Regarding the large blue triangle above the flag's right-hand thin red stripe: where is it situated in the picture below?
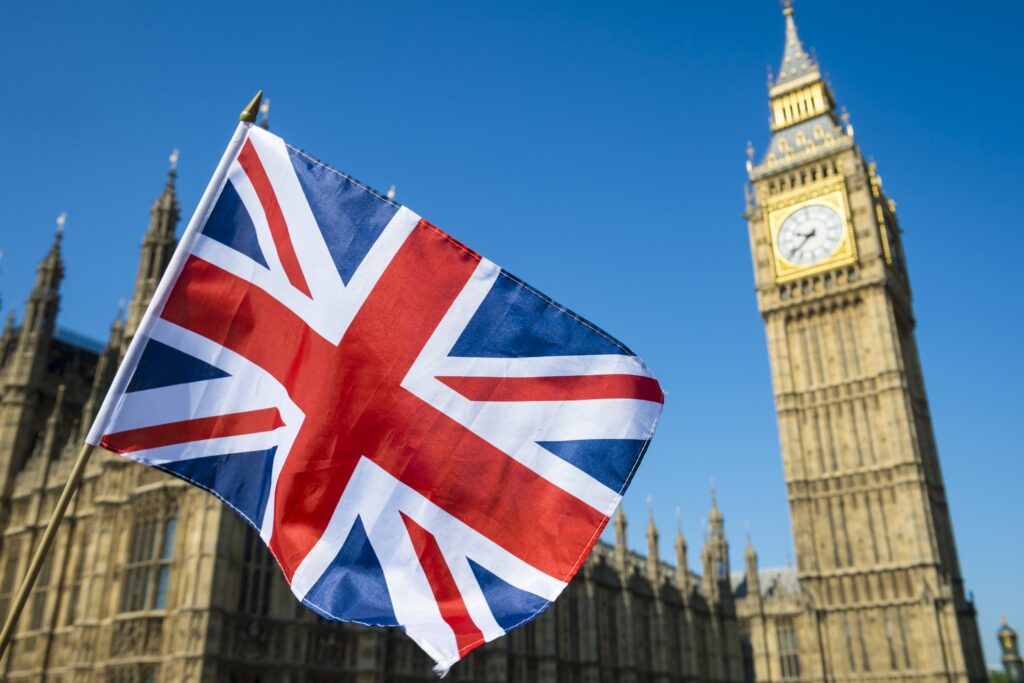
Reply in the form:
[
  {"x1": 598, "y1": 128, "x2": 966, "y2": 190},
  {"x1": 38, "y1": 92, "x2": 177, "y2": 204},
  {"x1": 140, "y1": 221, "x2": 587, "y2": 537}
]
[{"x1": 451, "y1": 270, "x2": 630, "y2": 358}]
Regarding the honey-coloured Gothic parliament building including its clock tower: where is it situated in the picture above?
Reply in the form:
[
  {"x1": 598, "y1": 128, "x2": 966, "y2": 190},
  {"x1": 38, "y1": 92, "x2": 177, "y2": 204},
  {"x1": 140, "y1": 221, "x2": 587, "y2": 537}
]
[{"x1": 0, "y1": 5, "x2": 985, "y2": 683}]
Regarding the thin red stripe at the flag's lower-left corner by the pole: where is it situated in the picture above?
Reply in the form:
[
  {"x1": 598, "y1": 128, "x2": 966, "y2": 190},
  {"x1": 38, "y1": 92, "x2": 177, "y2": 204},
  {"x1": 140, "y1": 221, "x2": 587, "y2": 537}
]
[{"x1": 100, "y1": 408, "x2": 285, "y2": 453}]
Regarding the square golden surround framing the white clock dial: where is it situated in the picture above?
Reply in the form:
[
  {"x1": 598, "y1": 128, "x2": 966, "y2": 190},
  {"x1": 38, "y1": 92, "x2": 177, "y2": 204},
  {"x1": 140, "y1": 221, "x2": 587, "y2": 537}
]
[{"x1": 764, "y1": 182, "x2": 857, "y2": 283}]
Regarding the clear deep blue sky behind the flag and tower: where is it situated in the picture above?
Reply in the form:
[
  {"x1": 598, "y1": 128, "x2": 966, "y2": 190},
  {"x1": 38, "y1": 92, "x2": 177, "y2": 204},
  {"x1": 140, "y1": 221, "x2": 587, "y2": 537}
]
[{"x1": 0, "y1": 0, "x2": 1024, "y2": 661}]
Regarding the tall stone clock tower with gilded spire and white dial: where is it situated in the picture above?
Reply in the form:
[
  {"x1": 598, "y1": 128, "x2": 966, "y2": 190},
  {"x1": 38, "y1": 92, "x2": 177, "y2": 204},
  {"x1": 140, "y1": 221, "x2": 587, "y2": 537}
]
[{"x1": 746, "y1": 3, "x2": 985, "y2": 682}]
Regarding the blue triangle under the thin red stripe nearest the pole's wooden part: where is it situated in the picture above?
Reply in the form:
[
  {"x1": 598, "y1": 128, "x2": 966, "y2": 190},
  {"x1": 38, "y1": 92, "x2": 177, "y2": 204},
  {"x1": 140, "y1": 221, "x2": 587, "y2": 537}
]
[{"x1": 159, "y1": 446, "x2": 278, "y2": 528}]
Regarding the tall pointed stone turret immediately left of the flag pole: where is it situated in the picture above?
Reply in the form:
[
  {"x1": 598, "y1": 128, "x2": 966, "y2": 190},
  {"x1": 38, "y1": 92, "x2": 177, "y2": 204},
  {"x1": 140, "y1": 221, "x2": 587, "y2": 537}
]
[{"x1": 125, "y1": 150, "x2": 179, "y2": 339}]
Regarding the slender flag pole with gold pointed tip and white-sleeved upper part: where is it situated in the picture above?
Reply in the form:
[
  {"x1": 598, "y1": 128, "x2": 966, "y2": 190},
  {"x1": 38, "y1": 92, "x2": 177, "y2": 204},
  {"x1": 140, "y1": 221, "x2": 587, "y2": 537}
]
[{"x1": 0, "y1": 90, "x2": 263, "y2": 658}]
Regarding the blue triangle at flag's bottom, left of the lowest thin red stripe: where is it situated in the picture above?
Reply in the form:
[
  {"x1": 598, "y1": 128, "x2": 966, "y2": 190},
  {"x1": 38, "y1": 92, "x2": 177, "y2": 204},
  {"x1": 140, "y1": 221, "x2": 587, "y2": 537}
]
[{"x1": 302, "y1": 517, "x2": 398, "y2": 626}]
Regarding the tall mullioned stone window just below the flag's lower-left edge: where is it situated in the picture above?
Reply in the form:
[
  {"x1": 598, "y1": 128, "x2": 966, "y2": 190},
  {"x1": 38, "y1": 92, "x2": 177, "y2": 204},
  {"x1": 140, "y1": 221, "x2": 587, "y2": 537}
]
[{"x1": 121, "y1": 507, "x2": 177, "y2": 612}]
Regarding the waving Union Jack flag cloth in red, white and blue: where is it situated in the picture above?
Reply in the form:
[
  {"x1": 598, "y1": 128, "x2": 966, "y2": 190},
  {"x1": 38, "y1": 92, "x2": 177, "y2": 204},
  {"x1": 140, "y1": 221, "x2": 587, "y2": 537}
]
[{"x1": 88, "y1": 126, "x2": 663, "y2": 672}]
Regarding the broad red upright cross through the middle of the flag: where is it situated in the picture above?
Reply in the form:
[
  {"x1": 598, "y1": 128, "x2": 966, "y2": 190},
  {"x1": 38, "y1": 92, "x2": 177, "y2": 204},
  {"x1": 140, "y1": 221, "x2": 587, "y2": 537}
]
[{"x1": 161, "y1": 236, "x2": 607, "y2": 580}]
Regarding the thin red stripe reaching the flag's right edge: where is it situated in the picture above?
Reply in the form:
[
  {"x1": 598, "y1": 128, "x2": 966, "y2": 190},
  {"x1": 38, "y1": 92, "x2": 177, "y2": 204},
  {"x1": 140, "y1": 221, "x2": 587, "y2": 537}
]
[{"x1": 437, "y1": 375, "x2": 665, "y2": 403}]
